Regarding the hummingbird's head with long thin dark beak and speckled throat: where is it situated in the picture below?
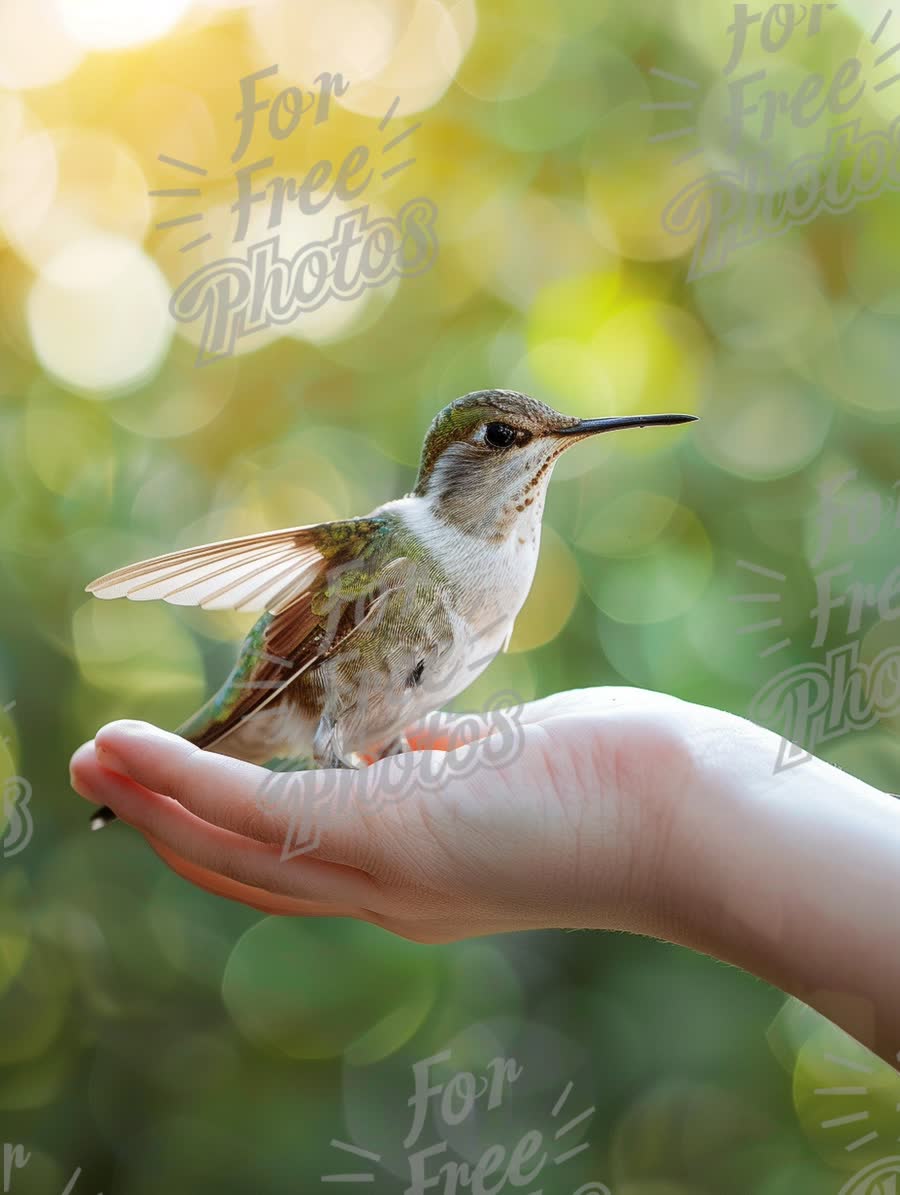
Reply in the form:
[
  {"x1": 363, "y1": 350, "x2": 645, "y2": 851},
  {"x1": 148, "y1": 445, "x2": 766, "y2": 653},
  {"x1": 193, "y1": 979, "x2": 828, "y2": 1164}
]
[{"x1": 412, "y1": 390, "x2": 696, "y2": 540}]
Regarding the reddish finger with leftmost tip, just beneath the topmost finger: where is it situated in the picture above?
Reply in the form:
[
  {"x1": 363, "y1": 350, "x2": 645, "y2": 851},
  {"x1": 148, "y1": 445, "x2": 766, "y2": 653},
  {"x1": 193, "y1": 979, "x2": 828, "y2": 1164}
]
[{"x1": 72, "y1": 752, "x2": 375, "y2": 907}]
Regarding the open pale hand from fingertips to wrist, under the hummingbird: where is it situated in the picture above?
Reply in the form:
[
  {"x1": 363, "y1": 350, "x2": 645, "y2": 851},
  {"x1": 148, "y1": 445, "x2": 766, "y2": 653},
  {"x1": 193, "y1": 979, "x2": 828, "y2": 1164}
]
[{"x1": 66, "y1": 688, "x2": 731, "y2": 943}]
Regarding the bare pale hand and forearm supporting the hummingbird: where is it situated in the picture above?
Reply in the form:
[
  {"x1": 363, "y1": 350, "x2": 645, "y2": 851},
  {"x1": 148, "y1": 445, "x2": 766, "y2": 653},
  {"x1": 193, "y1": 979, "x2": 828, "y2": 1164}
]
[{"x1": 72, "y1": 688, "x2": 900, "y2": 1066}]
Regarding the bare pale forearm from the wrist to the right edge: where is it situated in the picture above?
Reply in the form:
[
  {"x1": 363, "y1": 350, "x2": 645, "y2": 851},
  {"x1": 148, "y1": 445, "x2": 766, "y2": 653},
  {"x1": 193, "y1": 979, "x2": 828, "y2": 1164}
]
[{"x1": 665, "y1": 728, "x2": 900, "y2": 1065}]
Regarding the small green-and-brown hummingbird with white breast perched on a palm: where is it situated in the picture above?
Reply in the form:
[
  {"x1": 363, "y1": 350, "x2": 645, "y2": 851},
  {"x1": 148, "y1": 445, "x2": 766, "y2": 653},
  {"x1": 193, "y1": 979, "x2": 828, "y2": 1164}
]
[{"x1": 87, "y1": 390, "x2": 696, "y2": 829}]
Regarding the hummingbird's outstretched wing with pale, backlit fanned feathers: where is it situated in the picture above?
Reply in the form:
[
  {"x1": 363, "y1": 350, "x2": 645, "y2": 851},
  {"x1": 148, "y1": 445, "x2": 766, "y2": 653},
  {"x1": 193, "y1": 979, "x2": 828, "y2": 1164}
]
[{"x1": 87, "y1": 519, "x2": 346, "y2": 611}]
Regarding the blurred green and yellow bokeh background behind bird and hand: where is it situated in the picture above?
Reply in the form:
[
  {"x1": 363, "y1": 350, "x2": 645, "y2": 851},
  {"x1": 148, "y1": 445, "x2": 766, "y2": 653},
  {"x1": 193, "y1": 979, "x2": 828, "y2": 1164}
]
[{"x1": 0, "y1": 0, "x2": 900, "y2": 1195}]
